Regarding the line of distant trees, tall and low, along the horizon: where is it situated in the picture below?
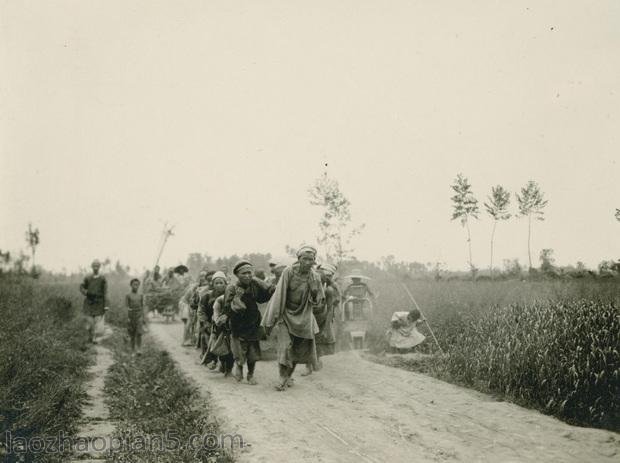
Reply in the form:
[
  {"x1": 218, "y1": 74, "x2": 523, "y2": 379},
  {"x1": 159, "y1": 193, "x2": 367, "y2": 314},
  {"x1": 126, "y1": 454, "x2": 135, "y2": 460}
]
[{"x1": 0, "y1": 173, "x2": 620, "y2": 279}]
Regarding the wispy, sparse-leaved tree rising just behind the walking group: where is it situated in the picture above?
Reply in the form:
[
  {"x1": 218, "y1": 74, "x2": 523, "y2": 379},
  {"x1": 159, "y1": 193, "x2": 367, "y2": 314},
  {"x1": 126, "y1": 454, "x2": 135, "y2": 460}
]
[{"x1": 308, "y1": 174, "x2": 364, "y2": 264}]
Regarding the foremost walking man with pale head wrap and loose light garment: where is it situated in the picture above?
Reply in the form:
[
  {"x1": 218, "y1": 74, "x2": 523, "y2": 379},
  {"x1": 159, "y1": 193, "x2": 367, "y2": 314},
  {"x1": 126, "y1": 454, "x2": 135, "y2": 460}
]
[{"x1": 262, "y1": 246, "x2": 325, "y2": 391}]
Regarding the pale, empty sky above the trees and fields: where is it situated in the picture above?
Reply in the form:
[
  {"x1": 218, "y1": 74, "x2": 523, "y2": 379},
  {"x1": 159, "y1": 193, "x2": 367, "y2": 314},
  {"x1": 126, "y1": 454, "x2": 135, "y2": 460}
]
[{"x1": 0, "y1": 0, "x2": 620, "y2": 271}]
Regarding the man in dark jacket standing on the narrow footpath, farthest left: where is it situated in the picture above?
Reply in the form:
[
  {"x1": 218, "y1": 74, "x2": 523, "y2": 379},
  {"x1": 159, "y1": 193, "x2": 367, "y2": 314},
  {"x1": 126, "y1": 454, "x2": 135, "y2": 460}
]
[{"x1": 80, "y1": 259, "x2": 108, "y2": 344}]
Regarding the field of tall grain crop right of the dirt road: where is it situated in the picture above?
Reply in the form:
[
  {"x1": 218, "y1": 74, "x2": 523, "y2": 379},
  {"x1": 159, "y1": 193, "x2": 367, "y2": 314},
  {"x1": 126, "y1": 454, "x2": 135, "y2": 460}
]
[{"x1": 370, "y1": 279, "x2": 620, "y2": 430}]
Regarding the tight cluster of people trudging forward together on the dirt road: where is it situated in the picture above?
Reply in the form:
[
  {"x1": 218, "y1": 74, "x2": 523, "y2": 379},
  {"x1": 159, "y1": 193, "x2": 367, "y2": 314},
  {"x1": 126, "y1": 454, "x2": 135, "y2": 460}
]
[{"x1": 172, "y1": 246, "x2": 339, "y2": 390}]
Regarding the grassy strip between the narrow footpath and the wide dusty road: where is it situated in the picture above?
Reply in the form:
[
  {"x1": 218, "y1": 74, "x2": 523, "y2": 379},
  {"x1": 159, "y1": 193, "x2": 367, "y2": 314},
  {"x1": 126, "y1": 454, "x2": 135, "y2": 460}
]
[{"x1": 105, "y1": 330, "x2": 234, "y2": 463}]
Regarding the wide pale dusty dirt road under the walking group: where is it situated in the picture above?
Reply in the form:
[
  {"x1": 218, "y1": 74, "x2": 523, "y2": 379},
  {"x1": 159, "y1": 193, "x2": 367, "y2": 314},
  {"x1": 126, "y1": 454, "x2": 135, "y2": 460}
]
[{"x1": 150, "y1": 322, "x2": 620, "y2": 463}]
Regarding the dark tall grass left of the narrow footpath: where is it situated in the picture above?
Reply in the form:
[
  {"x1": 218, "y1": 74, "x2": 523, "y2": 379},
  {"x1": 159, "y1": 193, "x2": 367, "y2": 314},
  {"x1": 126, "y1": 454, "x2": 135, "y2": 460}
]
[{"x1": 0, "y1": 276, "x2": 94, "y2": 462}]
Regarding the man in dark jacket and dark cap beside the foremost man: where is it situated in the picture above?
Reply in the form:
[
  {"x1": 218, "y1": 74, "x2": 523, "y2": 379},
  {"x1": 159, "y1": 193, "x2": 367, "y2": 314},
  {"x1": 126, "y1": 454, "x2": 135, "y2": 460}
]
[{"x1": 224, "y1": 260, "x2": 273, "y2": 385}]
